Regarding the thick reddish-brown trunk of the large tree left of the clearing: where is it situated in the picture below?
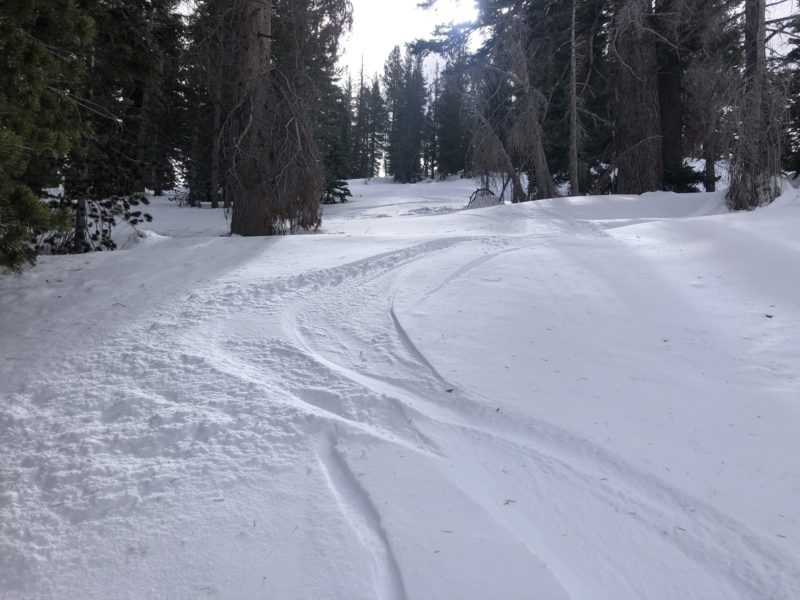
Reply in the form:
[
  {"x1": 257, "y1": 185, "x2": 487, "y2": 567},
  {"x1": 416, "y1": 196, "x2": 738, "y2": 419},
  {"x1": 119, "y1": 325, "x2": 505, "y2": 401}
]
[{"x1": 230, "y1": 0, "x2": 275, "y2": 236}]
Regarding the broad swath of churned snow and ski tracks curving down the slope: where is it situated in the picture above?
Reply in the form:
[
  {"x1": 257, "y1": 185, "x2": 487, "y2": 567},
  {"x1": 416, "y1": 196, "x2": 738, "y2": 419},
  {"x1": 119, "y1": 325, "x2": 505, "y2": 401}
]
[{"x1": 0, "y1": 183, "x2": 800, "y2": 600}]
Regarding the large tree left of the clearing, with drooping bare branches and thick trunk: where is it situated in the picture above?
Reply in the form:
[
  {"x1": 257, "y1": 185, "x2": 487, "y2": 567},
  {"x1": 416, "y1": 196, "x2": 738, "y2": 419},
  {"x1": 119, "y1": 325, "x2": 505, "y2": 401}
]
[{"x1": 187, "y1": 0, "x2": 351, "y2": 235}]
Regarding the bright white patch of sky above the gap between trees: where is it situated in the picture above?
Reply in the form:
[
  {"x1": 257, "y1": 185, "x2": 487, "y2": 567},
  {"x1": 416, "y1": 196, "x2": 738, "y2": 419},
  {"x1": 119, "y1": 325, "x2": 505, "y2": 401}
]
[{"x1": 342, "y1": 0, "x2": 476, "y2": 77}]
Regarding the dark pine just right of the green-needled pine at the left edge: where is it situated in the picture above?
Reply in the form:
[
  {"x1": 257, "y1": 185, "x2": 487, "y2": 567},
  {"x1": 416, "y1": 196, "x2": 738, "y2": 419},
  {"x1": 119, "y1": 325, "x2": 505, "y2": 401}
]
[{"x1": 56, "y1": 0, "x2": 188, "y2": 252}]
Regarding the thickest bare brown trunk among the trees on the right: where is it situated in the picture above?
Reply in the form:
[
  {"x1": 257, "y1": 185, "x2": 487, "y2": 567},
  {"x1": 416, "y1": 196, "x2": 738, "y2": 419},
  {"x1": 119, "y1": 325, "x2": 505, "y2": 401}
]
[{"x1": 614, "y1": 0, "x2": 664, "y2": 194}]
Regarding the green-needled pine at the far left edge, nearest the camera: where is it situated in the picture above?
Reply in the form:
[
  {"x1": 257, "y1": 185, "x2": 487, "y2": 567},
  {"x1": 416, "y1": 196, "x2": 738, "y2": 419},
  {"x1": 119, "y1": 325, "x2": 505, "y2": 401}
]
[{"x1": 0, "y1": 0, "x2": 94, "y2": 270}]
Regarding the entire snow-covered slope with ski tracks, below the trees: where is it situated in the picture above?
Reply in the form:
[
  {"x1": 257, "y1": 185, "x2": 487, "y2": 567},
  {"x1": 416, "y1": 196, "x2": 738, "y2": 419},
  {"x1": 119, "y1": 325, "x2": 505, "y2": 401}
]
[{"x1": 0, "y1": 181, "x2": 800, "y2": 600}]
